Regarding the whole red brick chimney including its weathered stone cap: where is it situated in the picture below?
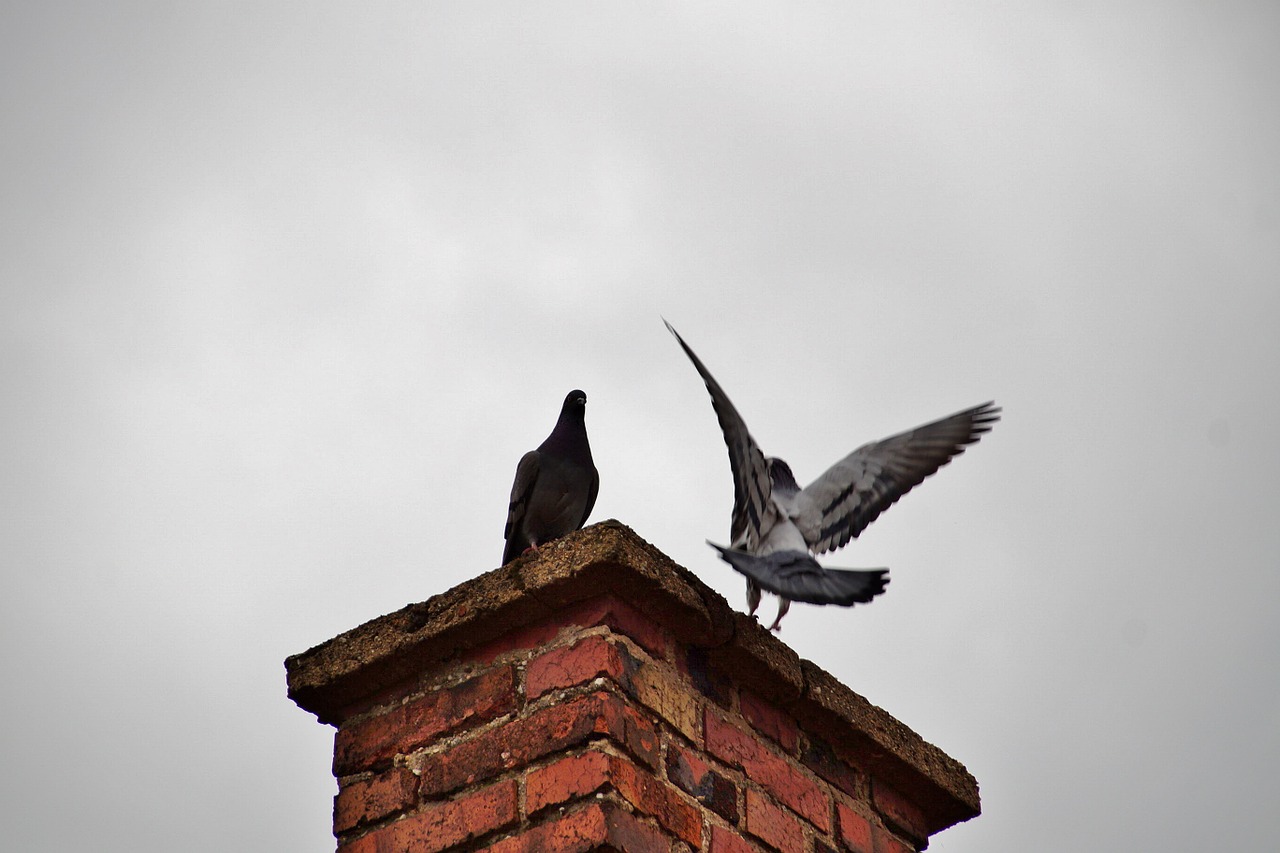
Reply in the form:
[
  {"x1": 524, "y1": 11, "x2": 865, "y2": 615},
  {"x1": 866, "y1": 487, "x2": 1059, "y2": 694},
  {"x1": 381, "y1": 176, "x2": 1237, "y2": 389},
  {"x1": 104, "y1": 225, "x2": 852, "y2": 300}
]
[{"x1": 285, "y1": 521, "x2": 979, "y2": 853}]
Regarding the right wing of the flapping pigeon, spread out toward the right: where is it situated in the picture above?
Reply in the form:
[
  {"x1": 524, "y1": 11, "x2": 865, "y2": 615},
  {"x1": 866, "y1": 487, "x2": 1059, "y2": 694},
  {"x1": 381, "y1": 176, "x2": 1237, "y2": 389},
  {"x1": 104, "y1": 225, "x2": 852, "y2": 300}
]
[{"x1": 792, "y1": 402, "x2": 1000, "y2": 553}]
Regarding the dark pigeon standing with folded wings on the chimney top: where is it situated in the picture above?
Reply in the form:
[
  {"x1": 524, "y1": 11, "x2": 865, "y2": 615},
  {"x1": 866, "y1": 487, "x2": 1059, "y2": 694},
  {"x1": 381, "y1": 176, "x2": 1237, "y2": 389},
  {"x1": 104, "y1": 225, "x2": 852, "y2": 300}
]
[{"x1": 502, "y1": 391, "x2": 600, "y2": 565}]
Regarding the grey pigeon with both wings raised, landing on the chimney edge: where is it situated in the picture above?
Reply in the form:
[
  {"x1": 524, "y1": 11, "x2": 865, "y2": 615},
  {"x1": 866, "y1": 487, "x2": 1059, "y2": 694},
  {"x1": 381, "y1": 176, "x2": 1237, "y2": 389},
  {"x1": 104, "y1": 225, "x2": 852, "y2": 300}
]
[{"x1": 663, "y1": 320, "x2": 1000, "y2": 630}]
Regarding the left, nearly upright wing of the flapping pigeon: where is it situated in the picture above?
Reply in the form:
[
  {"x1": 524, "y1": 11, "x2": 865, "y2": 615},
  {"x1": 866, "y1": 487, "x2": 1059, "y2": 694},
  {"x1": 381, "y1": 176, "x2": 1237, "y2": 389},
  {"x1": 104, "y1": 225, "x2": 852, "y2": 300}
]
[{"x1": 663, "y1": 320, "x2": 777, "y2": 551}]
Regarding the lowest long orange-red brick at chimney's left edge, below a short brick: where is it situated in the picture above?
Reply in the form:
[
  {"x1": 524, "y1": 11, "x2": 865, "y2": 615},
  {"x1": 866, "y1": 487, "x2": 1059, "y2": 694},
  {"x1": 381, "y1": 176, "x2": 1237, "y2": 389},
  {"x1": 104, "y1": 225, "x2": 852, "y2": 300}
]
[{"x1": 342, "y1": 779, "x2": 518, "y2": 853}]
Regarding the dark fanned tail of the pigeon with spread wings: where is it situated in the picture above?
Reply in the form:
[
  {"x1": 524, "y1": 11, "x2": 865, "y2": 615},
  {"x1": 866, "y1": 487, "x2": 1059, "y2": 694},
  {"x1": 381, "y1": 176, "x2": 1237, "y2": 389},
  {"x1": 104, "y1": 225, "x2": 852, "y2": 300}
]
[{"x1": 707, "y1": 542, "x2": 888, "y2": 607}]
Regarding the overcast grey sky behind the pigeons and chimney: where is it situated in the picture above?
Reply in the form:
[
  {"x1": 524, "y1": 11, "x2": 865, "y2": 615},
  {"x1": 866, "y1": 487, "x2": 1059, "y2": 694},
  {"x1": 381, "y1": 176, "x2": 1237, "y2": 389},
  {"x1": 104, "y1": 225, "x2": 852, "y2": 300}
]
[{"x1": 0, "y1": 3, "x2": 1280, "y2": 853}]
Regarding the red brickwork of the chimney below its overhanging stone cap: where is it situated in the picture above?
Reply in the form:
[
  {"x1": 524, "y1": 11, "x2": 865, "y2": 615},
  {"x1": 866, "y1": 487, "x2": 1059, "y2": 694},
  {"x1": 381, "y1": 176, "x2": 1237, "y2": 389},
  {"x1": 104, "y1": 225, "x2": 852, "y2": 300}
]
[{"x1": 289, "y1": 517, "x2": 977, "y2": 853}]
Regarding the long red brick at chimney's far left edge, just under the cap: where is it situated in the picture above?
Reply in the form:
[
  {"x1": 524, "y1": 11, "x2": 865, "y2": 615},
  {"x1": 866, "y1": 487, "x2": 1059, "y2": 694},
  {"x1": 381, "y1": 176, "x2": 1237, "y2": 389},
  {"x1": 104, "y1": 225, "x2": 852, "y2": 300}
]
[{"x1": 333, "y1": 666, "x2": 516, "y2": 777}]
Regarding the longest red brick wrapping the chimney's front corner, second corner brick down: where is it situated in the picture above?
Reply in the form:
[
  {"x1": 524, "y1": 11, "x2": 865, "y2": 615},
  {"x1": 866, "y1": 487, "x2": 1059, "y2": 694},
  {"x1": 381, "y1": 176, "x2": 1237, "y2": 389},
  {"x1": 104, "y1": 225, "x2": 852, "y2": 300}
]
[{"x1": 420, "y1": 692, "x2": 658, "y2": 797}]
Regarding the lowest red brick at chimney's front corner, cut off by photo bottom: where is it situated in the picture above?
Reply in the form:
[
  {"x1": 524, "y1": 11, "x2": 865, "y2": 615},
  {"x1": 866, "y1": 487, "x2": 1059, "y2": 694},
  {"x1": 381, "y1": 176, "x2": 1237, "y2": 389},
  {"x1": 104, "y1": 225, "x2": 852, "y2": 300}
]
[{"x1": 483, "y1": 800, "x2": 671, "y2": 853}]
